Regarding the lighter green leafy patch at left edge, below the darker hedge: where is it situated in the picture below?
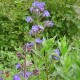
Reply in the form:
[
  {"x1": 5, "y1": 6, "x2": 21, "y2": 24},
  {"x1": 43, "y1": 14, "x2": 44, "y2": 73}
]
[{"x1": 0, "y1": 50, "x2": 18, "y2": 69}]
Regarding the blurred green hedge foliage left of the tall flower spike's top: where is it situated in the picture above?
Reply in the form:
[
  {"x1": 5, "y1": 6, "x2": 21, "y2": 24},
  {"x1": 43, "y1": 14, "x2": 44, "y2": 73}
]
[{"x1": 0, "y1": 0, "x2": 31, "y2": 51}]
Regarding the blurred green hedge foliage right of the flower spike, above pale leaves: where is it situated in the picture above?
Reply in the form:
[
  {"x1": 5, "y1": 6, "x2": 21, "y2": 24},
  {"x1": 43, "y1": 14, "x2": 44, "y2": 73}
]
[{"x1": 43, "y1": 0, "x2": 80, "y2": 39}]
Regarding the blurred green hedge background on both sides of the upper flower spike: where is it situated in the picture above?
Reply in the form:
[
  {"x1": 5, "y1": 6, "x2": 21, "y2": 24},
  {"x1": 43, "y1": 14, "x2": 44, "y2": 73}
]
[{"x1": 0, "y1": 0, "x2": 80, "y2": 51}]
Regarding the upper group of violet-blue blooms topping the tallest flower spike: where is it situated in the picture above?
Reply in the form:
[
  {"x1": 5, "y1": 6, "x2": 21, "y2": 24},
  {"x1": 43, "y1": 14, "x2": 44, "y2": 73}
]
[{"x1": 26, "y1": 1, "x2": 54, "y2": 36}]
